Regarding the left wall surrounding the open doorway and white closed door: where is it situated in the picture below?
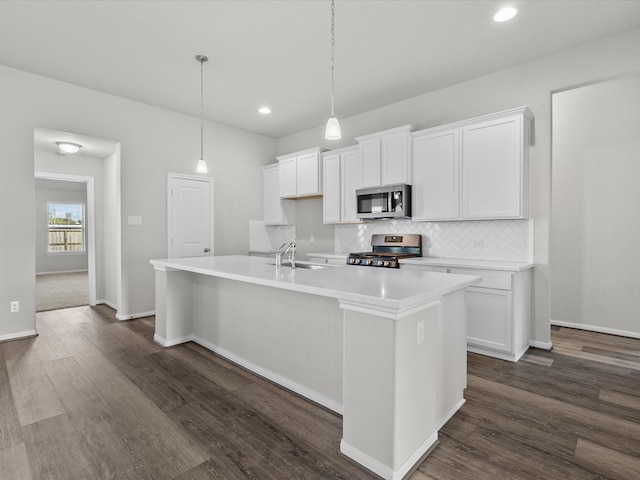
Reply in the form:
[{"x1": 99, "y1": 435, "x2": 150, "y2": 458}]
[{"x1": 0, "y1": 66, "x2": 275, "y2": 340}]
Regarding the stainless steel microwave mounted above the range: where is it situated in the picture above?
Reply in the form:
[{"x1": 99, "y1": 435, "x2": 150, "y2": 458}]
[{"x1": 356, "y1": 185, "x2": 411, "y2": 218}]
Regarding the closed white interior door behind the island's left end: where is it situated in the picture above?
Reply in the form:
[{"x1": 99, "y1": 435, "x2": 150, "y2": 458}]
[{"x1": 167, "y1": 173, "x2": 213, "y2": 258}]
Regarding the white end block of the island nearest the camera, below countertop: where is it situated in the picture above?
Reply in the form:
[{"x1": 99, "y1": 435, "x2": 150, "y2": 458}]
[{"x1": 340, "y1": 302, "x2": 442, "y2": 479}]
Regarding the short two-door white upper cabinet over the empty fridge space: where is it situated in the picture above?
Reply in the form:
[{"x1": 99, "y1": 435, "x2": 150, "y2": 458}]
[{"x1": 277, "y1": 148, "x2": 326, "y2": 198}]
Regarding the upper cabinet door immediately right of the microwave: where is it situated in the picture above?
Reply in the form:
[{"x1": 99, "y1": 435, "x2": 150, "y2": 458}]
[{"x1": 412, "y1": 129, "x2": 460, "y2": 220}]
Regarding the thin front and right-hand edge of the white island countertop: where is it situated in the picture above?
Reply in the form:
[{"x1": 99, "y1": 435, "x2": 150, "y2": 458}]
[{"x1": 149, "y1": 257, "x2": 482, "y2": 318}]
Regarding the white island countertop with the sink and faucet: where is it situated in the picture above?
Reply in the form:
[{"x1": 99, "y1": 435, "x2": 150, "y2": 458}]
[{"x1": 150, "y1": 255, "x2": 481, "y2": 310}]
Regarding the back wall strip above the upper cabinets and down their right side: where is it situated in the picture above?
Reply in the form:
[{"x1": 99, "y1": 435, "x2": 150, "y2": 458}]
[{"x1": 277, "y1": 29, "x2": 640, "y2": 346}]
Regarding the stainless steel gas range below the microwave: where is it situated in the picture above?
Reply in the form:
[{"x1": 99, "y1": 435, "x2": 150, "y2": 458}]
[{"x1": 347, "y1": 233, "x2": 422, "y2": 268}]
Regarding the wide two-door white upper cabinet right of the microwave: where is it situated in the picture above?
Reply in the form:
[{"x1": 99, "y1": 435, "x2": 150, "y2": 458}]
[{"x1": 413, "y1": 107, "x2": 533, "y2": 221}]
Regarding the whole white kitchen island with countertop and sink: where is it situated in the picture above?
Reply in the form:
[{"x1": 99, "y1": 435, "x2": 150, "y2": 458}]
[{"x1": 151, "y1": 256, "x2": 480, "y2": 479}]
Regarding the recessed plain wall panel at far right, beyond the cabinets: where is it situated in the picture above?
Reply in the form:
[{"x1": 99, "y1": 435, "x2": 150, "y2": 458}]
[{"x1": 550, "y1": 75, "x2": 640, "y2": 338}]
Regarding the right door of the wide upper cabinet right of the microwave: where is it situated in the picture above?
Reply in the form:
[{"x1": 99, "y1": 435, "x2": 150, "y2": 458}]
[{"x1": 462, "y1": 116, "x2": 523, "y2": 218}]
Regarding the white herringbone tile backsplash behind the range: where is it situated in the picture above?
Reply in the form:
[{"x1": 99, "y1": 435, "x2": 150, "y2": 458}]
[{"x1": 335, "y1": 220, "x2": 533, "y2": 262}]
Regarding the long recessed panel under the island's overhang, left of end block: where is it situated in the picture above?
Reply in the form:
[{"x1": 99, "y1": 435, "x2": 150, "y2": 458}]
[{"x1": 192, "y1": 275, "x2": 343, "y2": 413}]
